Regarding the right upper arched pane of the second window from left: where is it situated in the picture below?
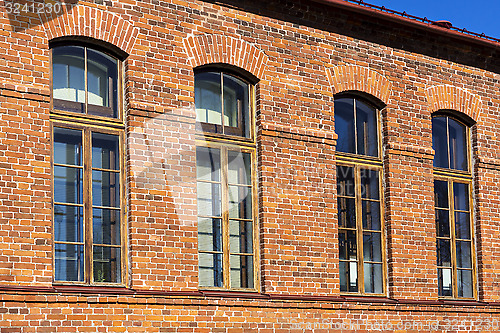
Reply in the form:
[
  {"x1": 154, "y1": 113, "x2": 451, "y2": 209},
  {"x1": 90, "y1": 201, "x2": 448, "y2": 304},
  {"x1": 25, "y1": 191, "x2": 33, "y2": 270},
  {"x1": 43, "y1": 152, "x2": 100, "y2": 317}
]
[{"x1": 223, "y1": 74, "x2": 250, "y2": 137}]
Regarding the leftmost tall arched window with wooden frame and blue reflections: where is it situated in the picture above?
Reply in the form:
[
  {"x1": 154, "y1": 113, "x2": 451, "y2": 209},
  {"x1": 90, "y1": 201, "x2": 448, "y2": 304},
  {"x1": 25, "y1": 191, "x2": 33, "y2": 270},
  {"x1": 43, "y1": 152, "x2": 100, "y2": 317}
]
[{"x1": 51, "y1": 42, "x2": 126, "y2": 285}]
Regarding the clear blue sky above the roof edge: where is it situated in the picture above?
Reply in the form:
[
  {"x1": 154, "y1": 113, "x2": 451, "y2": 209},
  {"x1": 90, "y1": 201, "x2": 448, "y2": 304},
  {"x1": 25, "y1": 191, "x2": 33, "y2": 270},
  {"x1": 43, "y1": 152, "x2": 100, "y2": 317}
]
[{"x1": 364, "y1": 0, "x2": 500, "y2": 38}]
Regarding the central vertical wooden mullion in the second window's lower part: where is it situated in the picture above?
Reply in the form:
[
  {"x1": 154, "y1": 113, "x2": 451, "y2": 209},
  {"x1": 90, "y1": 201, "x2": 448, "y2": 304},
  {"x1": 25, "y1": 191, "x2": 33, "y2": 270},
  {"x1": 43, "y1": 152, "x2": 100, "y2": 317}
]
[{"x1": 221, "y1": 147, "x2": 231, "y2": 289}]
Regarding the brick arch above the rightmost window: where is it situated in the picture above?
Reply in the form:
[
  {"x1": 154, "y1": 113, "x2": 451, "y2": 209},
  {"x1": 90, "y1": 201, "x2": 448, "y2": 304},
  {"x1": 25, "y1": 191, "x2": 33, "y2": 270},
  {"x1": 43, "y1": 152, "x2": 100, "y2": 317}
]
[{"x1": 425, "y1": 85, "x2": 483, "y2": 122}]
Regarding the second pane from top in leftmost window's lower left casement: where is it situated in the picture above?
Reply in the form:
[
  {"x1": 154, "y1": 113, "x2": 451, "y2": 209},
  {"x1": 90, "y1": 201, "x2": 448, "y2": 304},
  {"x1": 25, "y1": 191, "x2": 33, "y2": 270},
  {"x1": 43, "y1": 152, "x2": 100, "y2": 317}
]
[{"x1": 54, "y1": 166, "x2": 83, "y2": 204}]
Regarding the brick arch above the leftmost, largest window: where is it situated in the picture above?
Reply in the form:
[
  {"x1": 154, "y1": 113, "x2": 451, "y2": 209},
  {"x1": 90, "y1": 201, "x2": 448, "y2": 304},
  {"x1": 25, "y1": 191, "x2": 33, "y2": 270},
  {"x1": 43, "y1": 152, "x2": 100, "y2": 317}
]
[{"x1": 40, "y1": 5, "x2": 139, "y2": 54}]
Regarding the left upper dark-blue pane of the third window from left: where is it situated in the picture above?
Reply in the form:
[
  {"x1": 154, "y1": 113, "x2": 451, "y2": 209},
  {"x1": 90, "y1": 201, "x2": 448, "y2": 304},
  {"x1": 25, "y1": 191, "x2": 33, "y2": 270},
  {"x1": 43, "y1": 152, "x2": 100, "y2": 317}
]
[{"x1": 334, "y1": 98, "x2": 356, "y2": 154}]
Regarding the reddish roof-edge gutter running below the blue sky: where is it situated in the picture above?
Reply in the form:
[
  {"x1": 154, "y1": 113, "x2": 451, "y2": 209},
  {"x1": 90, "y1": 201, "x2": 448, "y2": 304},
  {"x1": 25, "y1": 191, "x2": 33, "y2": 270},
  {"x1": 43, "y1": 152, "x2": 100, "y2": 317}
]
[{"x1": 312, "y1": 0, "x2": 500, "y2": 49}]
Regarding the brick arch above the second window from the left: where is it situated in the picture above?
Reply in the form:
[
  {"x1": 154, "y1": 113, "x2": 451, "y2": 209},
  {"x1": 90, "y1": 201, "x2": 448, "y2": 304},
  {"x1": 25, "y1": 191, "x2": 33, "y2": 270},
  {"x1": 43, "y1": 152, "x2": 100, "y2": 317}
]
[{"x1": 184, "y1": 34, "x2": 268, "y2": 79}]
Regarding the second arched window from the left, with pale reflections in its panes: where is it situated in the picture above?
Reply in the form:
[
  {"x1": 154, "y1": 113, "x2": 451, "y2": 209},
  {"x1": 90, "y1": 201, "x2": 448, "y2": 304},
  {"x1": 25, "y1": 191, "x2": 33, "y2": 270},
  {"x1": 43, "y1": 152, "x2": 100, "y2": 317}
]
[{"x1": 194, "y1": 69, "x2": 257, "y2": 289}]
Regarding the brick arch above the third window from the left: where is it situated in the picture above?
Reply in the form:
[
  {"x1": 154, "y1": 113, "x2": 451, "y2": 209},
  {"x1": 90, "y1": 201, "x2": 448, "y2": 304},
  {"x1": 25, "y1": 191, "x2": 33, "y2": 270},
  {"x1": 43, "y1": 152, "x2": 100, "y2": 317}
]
[{"x1": 326, "y1": 65, "x2": 391, "y2": 104}]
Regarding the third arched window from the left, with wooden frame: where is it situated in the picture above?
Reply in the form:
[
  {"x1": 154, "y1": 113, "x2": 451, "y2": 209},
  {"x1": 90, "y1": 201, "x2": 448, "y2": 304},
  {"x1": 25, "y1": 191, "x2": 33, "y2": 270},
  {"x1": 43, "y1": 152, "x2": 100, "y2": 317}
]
[{"x1": 334, "y1": 96, "x2": 386, "y2": 295}]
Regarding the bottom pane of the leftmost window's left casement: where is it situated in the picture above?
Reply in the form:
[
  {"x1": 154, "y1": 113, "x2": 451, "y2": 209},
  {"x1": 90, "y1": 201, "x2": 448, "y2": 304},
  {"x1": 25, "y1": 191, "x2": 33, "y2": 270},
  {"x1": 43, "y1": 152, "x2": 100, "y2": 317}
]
[{"x1": 54, "y1": 244, "x2": 85, "y2": 281}]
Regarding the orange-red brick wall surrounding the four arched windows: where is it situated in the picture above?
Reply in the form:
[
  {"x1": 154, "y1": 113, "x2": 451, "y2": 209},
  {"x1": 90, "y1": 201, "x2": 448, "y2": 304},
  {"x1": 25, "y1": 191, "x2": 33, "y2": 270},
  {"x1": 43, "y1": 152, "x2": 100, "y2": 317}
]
[{"x1": 0, "y1": 0, "x2": 500, "y2": 333}]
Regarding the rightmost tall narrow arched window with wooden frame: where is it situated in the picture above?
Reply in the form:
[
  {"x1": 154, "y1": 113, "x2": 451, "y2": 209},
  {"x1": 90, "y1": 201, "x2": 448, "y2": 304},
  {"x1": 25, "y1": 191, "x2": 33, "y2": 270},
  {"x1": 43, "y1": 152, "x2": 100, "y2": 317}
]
[{"x1": 432, "y1": 113, "x2": 475, "y2": 298}]
